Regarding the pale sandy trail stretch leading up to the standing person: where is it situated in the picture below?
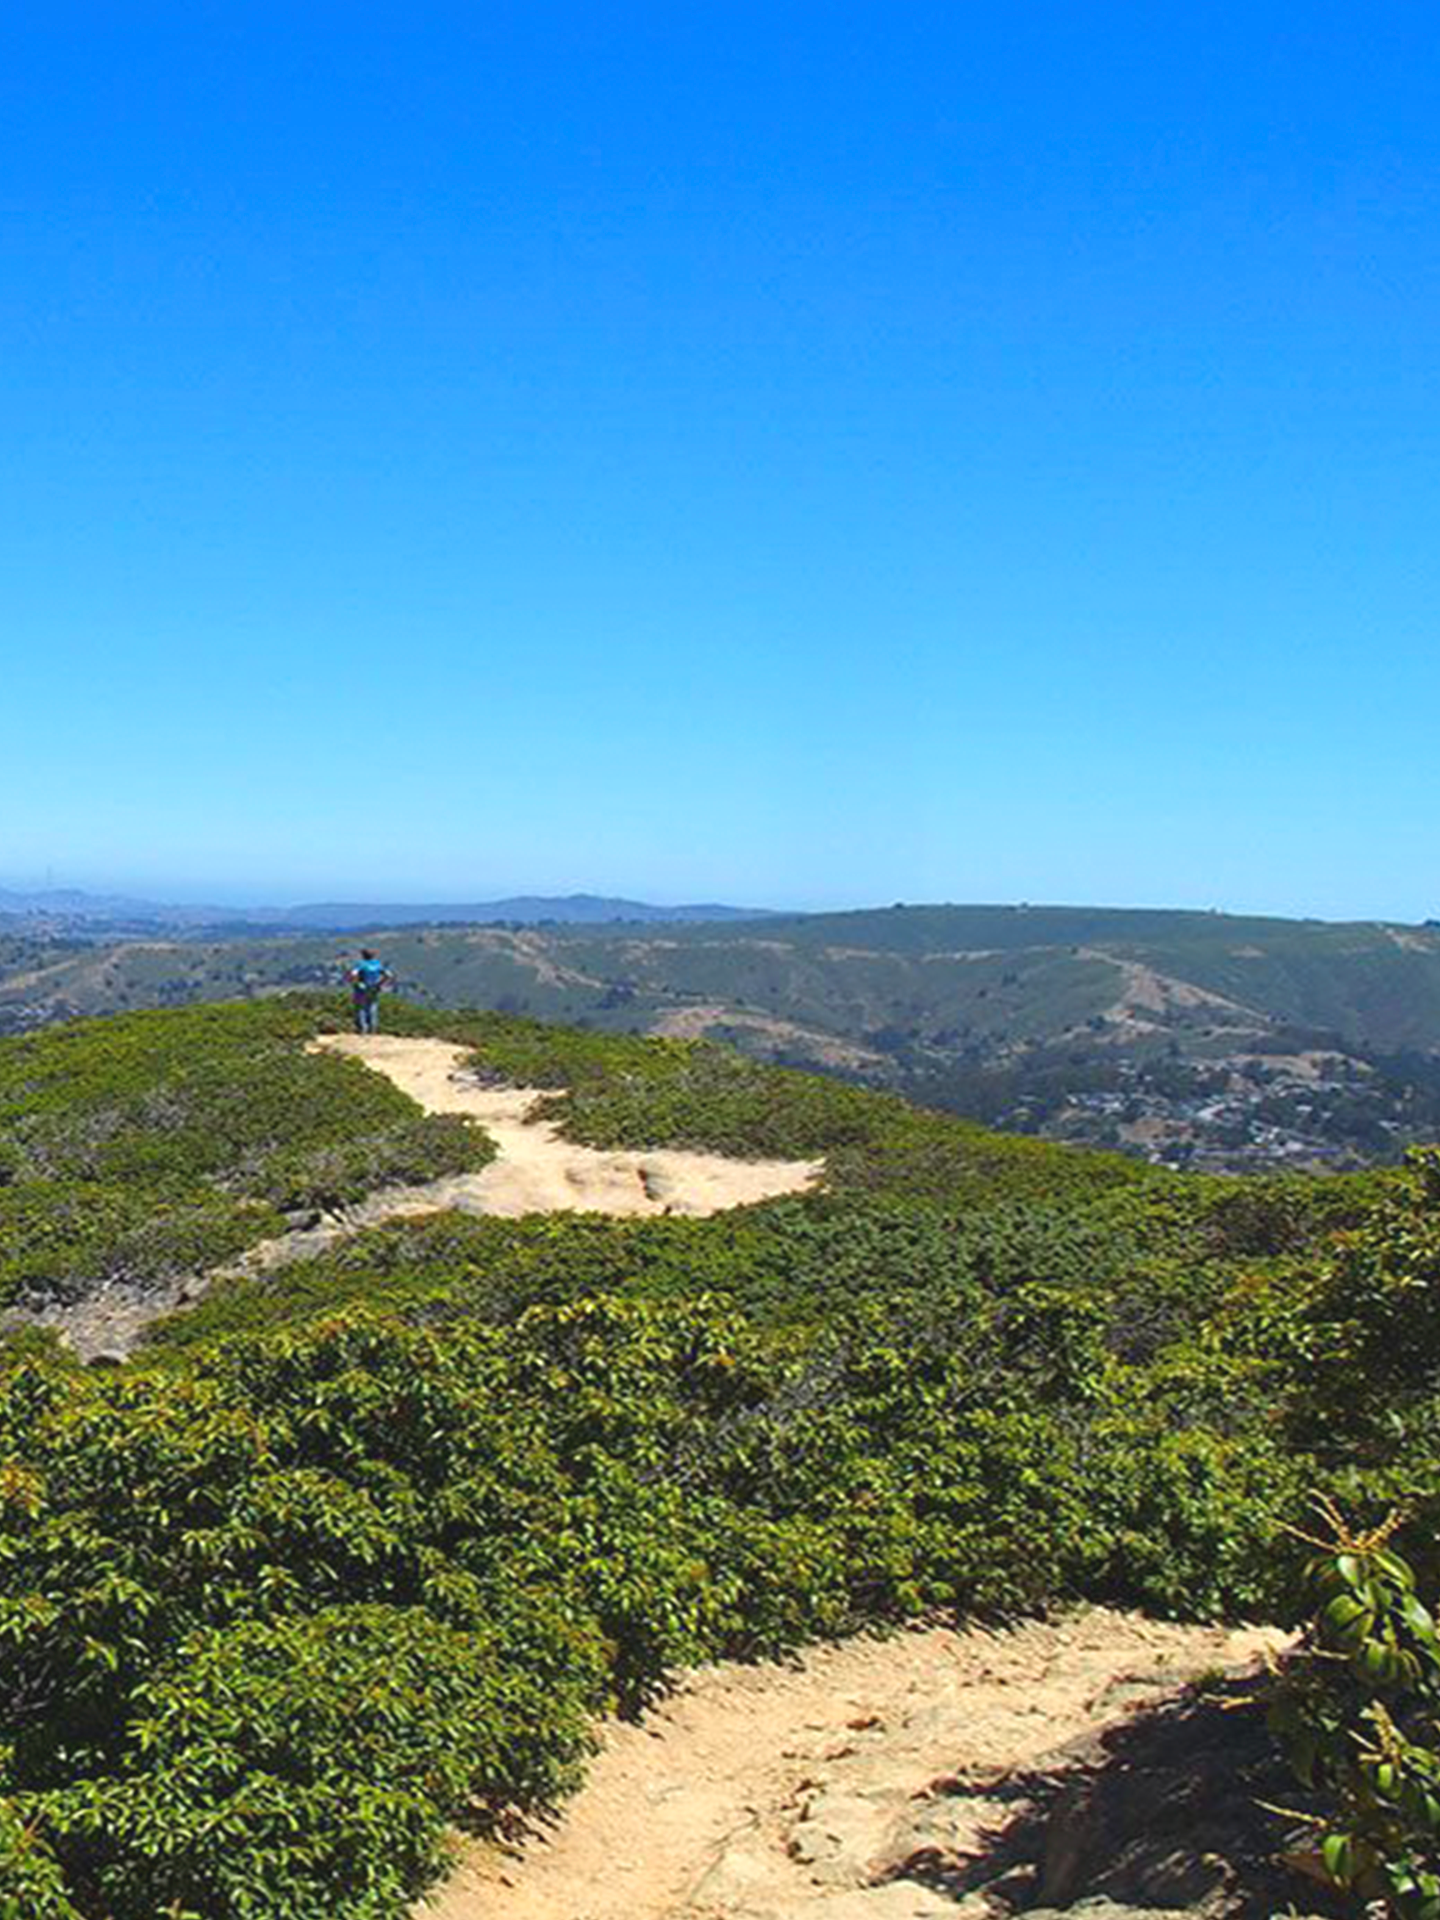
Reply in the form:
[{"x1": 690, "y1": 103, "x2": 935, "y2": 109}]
[{"x1": 313, "y1": 1033, "x2": 824, "y2": 1223}]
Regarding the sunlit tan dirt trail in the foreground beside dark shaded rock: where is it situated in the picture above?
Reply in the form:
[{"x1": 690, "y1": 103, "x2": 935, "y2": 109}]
[{"x1": 420, "y1": 1609, "x2": 1283, "y2": 1920}]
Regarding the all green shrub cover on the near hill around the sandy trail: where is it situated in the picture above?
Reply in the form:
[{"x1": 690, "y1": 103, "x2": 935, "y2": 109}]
[{"x1": 0, "y1": 998, "x2": 1440, "y2": 1920}]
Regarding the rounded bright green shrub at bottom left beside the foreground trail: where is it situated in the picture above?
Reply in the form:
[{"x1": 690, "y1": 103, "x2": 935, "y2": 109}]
[{"x1": 44, "y1": 1605, "x2": 580, "y2": 1920}]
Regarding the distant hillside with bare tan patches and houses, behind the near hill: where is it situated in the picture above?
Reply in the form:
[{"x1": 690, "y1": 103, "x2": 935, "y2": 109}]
[{"x1": 0, "y1": 902, "x2": 1440, "y2": 1169}]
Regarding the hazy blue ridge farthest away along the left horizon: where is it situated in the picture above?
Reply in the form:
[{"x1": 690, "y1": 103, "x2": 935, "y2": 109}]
[{"x1": 0, "y1": 887, "x2": 768, "y2": 933}]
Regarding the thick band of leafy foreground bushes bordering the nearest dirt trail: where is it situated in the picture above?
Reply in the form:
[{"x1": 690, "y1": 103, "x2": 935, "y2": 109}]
[{"x1": 0, "y1": 1284, "x2": 1328, "y2": 1920}]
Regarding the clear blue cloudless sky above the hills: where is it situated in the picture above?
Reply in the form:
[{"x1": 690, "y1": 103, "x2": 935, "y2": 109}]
[{"x1": 0, "y1": 0, "x2": 1440, "y2": 918}]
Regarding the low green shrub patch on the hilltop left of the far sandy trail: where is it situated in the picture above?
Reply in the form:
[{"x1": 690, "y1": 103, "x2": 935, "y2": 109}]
[{"x1": 0, "y1": 1002, "x2": 492, "y2": 1306}]
